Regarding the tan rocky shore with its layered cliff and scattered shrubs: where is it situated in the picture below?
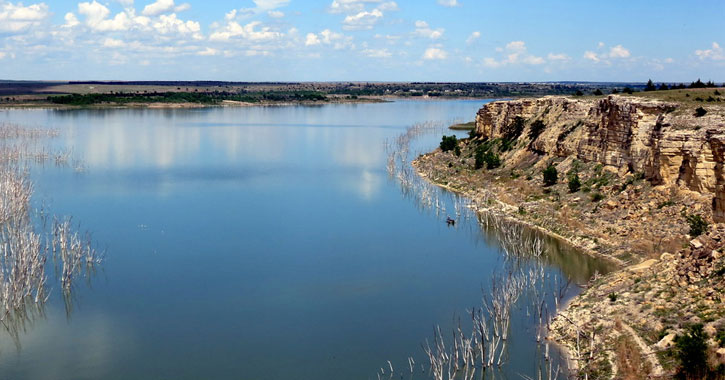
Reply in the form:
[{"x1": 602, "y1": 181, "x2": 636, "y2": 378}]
[{"x1": 414, "y1": 93, "x2": 725, "y2": 379}]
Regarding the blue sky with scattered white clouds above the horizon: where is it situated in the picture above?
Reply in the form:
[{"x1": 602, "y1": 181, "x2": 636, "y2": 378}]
[{"x1": 0, "y1": 0, "x2": 725, "y2": 82}]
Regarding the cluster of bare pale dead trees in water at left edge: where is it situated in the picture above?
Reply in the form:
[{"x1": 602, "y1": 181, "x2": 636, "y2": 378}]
[{"x1": 0, "y1": 124, "x2": 101, "y2": 336}]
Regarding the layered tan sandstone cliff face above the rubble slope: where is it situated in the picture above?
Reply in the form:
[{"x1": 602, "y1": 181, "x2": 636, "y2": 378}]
[{"x1": 476, "y1": 95, "x2": 725, "y2": 222}]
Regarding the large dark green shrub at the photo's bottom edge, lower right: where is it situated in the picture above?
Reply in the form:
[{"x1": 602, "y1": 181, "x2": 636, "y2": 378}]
[{"x1": 675, "y1": 324, "x2": 708, "y2": 379}]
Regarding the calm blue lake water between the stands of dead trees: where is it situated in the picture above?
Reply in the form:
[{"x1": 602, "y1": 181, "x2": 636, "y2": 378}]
[{"x1": 0, "y1": 100, "x2": 600, "y2": 380}]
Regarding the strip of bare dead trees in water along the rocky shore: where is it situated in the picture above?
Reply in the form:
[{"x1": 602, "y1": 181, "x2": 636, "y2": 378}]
[{"x1": 377, "y1": 123, "x2": 570, "y2": 380}]
